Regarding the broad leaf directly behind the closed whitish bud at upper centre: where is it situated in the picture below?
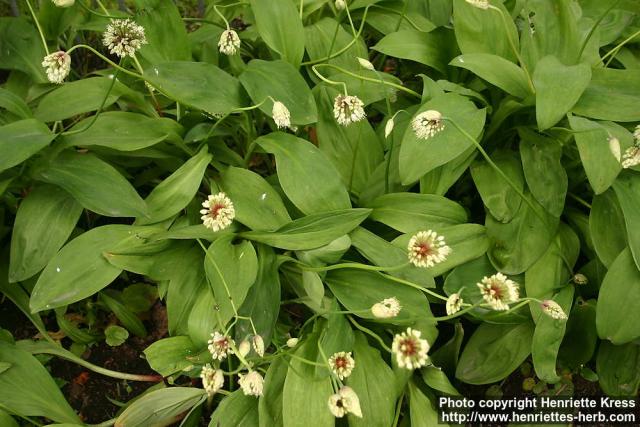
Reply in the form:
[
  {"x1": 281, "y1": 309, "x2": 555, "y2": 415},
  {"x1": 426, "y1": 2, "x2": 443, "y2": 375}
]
[{"x1": 239, "y1": 59, "x2": 318, "y2": 125}]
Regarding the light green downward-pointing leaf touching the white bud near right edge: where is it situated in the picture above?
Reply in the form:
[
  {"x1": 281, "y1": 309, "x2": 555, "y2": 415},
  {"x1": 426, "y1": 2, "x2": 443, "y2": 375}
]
[{"x1": 569, "y1": 117, "x2": 622, "y2": 194}]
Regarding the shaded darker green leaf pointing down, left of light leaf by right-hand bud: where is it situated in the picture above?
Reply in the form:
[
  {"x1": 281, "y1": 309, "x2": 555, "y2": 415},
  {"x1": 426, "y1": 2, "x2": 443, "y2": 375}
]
[{"x1": 518, "y1": 128, "x2": 568, "y2": 217}]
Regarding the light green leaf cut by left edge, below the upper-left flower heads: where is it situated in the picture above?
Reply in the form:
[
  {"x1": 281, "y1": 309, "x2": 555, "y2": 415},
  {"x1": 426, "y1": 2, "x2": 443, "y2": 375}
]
[{"x1": 0, "y1": 119, "x2": 55, "y2": 172}]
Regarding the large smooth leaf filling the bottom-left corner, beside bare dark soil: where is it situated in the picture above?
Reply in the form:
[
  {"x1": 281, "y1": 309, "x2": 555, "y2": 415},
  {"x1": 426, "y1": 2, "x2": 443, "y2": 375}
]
[{"x1": 0, "y1": 341, "x2": 80, "y2": 423}]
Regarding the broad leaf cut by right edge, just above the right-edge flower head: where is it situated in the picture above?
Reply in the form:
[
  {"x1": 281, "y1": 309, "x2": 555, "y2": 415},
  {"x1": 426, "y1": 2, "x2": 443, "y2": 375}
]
[{"x1": 572, "y1": 68, "x2": 640, "y2": 122}]
